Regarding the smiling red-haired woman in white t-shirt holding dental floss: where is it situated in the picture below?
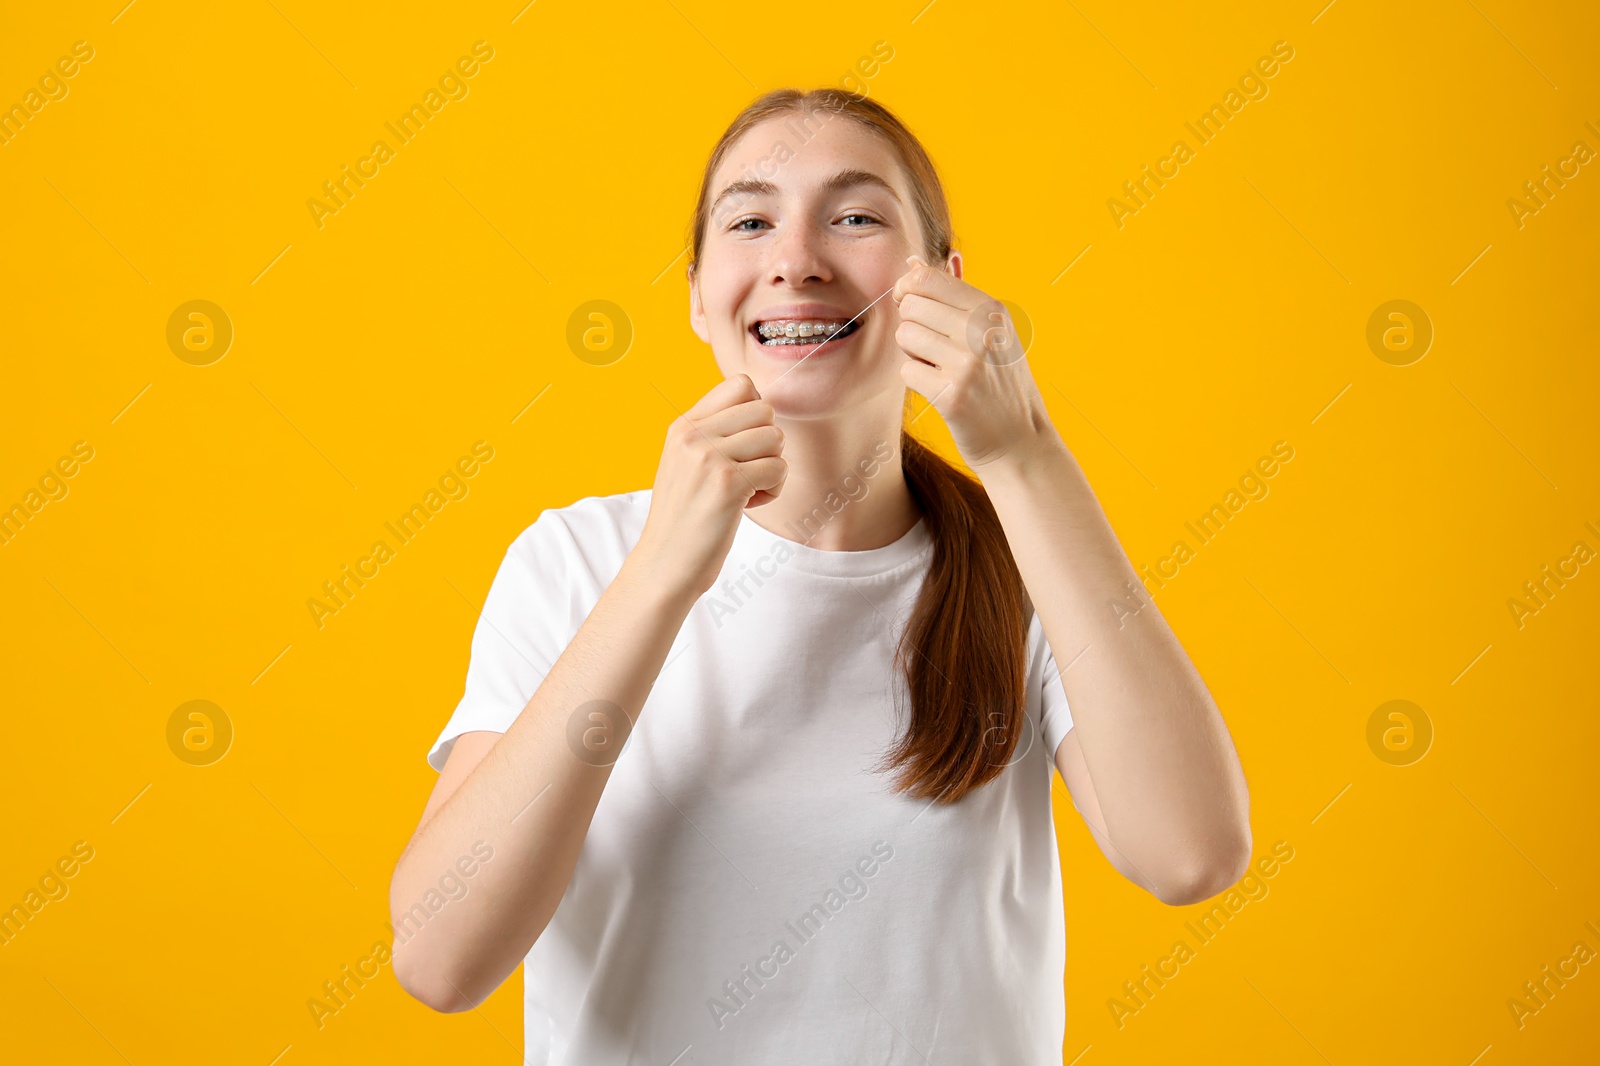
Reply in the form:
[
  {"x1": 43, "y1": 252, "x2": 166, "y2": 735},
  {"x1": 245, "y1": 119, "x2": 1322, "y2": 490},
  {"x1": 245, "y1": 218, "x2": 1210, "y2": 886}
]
[{"x1": 390, "y1": 90, "x2": 1251, "y2": 1066}]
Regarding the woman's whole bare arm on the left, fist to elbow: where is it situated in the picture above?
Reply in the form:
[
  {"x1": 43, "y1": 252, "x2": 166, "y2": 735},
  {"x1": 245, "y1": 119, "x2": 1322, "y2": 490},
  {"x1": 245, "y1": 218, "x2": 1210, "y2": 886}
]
[{"x1": 389, "y1": 382, "x2": 789, "y2": 1012}]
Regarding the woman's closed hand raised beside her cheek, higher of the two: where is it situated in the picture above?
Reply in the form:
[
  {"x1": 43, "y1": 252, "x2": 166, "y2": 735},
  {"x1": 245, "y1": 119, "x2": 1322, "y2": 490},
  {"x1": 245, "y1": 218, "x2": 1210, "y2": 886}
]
[{"x1": 893, "y1": 256, "x2": 1059, "y2": 472}]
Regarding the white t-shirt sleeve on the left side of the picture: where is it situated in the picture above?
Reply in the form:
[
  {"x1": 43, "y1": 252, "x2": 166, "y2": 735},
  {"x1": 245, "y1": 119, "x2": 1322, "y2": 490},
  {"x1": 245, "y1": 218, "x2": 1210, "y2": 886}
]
[{"x1": 427, "y1": 511, "x2": 573, "y2": 770}]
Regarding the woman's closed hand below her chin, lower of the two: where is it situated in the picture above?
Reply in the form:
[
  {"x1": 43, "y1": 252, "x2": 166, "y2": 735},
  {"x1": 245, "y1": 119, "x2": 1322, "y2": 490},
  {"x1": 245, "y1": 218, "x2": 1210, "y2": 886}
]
[{"x1": 630, "y1": 375, "x2": 789, "y2": 599}]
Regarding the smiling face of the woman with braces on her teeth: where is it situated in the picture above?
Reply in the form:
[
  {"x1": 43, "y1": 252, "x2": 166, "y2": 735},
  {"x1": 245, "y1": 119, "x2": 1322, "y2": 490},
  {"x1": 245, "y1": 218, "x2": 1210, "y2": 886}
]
[{"x1": 690, "y1": 112, "x2": 958, "y2": 418}]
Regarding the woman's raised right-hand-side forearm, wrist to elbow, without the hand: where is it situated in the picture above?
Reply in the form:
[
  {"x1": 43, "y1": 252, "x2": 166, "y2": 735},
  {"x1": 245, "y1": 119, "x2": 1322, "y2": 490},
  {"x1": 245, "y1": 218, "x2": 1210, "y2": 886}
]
[{"x1": 979, "y1": 429, "x2": 1250, "y2": 898}]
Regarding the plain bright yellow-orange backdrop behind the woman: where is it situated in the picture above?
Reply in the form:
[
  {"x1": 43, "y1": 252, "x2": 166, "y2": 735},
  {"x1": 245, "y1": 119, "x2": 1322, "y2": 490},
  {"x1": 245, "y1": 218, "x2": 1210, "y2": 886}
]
[{"x1": 0, "y1": 0, "x2": 1600, "y2": 1066}]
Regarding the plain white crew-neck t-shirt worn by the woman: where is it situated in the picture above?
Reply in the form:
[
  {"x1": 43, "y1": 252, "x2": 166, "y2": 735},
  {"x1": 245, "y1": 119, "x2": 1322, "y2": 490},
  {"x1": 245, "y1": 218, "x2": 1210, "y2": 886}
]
[{"x1": 429, "y1": 488, "x2": 1072, "y2": 1066}]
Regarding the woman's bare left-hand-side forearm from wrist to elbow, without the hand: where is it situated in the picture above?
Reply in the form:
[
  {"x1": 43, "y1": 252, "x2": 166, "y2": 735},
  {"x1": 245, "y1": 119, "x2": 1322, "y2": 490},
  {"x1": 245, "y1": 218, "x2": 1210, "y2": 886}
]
[{"x1": 390, "y1": 557, "x2": 694, "y2": 1010}]
